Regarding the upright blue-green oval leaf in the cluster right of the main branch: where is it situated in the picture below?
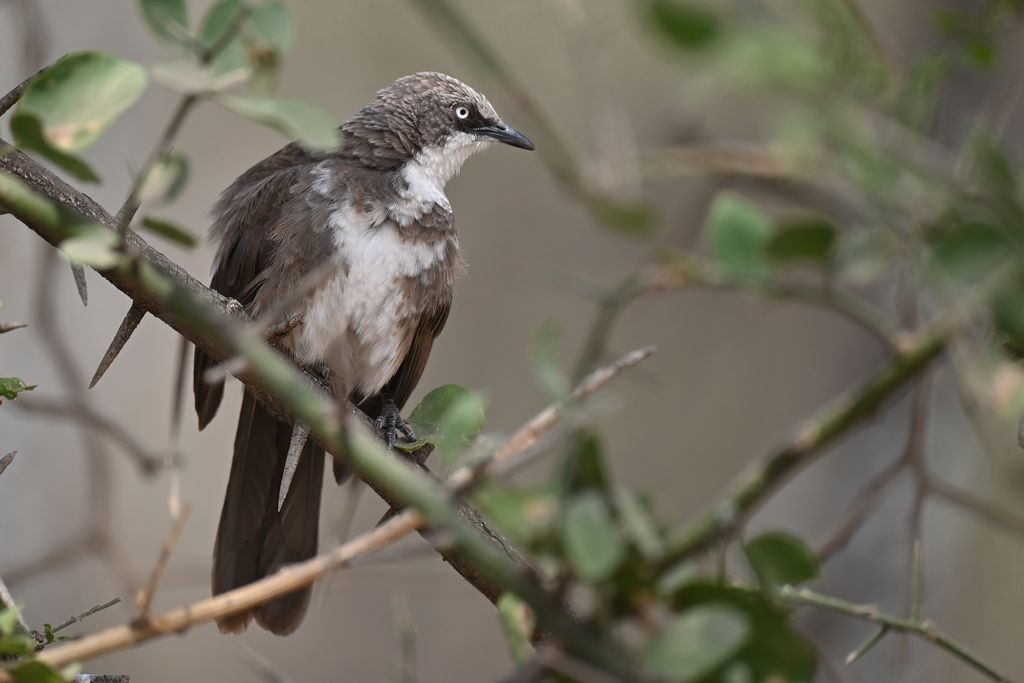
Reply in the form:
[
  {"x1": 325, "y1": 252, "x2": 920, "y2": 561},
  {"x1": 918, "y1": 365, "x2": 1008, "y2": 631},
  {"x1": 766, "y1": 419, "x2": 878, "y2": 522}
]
[{"x1": 562, "y1": 490, "x2": 626, "y2": 583}]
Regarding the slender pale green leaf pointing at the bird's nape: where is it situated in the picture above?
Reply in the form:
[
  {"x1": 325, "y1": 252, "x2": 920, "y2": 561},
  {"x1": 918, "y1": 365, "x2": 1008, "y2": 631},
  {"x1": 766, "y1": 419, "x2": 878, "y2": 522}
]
[{"x1": 218, "y1": 95, "x2": 340, "y2": 151}]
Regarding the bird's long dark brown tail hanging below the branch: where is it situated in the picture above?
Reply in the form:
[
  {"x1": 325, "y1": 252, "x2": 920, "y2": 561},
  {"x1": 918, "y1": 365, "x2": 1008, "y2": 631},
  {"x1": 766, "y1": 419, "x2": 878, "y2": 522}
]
[{"x1": 213, "y1": 391, "x2": 324, "y2": 636}]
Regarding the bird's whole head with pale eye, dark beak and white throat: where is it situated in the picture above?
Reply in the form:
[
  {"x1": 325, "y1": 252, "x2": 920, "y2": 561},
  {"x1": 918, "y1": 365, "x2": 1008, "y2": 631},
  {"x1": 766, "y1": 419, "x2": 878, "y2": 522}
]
[{"x1": 342, "y1": 72, "x2": 534, "y2": 184}]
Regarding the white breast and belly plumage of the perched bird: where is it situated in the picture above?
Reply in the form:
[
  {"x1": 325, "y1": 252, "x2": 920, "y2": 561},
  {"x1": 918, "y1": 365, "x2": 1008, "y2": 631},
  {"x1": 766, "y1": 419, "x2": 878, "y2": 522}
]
[{"x1": 295, "y1": 204, "x2": 458, "y2": 395}]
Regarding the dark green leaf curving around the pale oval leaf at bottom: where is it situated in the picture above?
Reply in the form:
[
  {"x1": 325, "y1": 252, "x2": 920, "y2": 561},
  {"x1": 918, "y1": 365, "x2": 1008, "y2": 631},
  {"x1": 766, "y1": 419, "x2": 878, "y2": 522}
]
[{"x1": 674, "y1": 581, "x2": 817, "y2": 683}]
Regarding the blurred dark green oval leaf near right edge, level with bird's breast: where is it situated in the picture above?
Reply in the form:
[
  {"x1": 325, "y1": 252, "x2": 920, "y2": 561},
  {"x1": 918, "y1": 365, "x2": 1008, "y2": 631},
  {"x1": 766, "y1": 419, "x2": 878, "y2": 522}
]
[{"x1": 932, "y1": 220, "x2": 1014, "y2": 284}]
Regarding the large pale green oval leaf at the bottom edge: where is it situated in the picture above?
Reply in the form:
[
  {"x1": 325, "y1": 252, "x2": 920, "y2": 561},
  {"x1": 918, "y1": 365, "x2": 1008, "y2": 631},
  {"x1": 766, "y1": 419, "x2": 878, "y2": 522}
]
[{"x1": 643, "y1": 603, "x2": 751, "y2": 683}]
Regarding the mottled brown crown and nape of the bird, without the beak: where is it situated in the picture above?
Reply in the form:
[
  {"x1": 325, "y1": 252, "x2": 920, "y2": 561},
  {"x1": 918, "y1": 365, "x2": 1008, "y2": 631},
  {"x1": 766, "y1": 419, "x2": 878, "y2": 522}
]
[{"x1": 341, "y1": 72, "x2": 501, "y2": 170}]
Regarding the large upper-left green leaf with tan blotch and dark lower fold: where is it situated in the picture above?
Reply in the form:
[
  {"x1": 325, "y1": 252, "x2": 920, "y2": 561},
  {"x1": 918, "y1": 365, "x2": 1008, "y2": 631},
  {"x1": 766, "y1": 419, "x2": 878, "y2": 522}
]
[{"x1": 11, "y1": 52, "x2": 145, "y2": 180}]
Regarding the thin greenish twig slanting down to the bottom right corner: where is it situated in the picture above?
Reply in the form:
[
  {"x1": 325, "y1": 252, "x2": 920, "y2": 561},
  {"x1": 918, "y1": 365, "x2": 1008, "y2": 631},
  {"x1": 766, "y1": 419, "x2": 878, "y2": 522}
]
[{"x1": 779, "y1": 586, "x2": 1012, "y2": 683}]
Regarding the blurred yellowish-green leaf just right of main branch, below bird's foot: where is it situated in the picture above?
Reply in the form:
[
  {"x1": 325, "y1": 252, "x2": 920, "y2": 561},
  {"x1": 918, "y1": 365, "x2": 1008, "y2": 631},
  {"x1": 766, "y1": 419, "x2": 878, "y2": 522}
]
[{"x1": 473, "y1": 484, "x2": 558, "y2": 547}]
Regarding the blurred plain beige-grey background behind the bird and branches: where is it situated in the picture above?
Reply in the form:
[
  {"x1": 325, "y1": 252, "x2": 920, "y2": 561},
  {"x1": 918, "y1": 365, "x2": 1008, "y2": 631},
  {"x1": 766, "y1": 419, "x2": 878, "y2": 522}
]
[{"x1": 0, "y1": 0, "x2": 1024, "y2": 683}]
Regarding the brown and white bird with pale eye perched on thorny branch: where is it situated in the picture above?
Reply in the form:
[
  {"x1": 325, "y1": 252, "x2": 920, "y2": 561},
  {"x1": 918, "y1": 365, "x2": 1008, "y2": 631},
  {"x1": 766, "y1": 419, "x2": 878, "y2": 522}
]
[{"x1": 193, "y1": 72, "x2": 535, "y2": 635}]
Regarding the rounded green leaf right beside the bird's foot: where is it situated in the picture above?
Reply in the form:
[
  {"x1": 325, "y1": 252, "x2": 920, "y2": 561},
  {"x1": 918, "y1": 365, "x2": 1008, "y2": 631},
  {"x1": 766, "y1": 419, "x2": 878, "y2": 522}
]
[{"x1": 409, "y1": 384, "x2": 484, "y2": 459}]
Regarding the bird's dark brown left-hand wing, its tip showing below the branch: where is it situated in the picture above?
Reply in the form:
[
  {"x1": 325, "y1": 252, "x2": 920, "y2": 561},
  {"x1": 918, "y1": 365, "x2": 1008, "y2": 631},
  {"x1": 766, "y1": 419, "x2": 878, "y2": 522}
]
[{"x1": 193, "y1": 143, "x2": 317, "y2": 429}]
